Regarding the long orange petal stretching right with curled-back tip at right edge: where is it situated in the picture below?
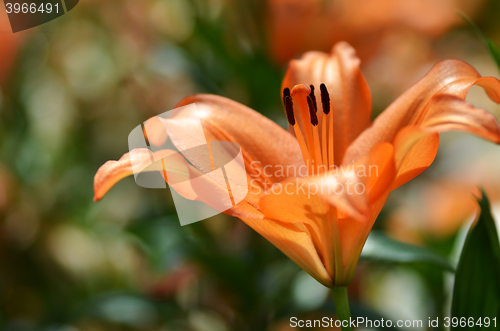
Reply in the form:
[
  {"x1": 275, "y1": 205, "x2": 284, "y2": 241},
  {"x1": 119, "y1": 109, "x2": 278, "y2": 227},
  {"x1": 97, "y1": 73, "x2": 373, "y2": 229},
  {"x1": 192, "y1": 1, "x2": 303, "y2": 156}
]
[{"x1": 343, "y1": 60, "x2": 500, "y2": 171}]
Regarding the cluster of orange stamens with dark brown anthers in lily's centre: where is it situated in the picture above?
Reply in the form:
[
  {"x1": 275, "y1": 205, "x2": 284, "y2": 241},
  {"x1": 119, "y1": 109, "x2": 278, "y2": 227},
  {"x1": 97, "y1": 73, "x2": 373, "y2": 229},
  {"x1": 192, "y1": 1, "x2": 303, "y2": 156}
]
[{"x1": 283, "y1": 84, "x2": 335, "y2": 176}]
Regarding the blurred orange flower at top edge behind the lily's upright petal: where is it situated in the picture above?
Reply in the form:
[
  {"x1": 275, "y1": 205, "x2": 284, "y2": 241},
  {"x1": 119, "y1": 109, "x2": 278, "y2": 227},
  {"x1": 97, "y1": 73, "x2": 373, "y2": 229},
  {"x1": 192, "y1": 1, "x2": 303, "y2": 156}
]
[{"x1": 267, "y1": 0, "x2": 484, "y2": 63}]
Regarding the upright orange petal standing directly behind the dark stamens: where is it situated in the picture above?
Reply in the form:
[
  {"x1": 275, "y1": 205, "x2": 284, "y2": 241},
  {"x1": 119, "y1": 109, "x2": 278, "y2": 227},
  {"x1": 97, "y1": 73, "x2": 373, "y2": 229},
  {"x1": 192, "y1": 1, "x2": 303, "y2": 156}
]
[{"x1": 282, "y1": 42, "x2": 371, "y2": 164}]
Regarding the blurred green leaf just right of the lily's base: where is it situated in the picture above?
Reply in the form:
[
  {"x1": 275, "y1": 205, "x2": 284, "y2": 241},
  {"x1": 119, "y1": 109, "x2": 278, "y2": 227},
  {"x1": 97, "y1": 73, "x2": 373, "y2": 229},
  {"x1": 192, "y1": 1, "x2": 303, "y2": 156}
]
[{"x1": 361, "y1": 231, "x2": 455, "y2": 272}]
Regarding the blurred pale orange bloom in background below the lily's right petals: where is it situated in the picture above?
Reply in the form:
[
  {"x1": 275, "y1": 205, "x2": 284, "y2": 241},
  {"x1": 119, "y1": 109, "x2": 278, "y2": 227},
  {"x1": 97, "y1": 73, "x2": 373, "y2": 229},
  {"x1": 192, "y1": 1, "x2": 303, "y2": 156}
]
[{"x1": 387, "y1": 143, "x2": 500, "y2": 244}]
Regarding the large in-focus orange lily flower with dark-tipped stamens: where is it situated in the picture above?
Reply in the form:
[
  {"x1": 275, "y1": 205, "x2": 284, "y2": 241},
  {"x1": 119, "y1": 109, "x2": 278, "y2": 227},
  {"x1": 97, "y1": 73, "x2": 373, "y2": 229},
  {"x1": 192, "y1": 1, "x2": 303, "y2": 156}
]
[{"x1": 94, "y1": 42, "x2": 500, "y2": 287}]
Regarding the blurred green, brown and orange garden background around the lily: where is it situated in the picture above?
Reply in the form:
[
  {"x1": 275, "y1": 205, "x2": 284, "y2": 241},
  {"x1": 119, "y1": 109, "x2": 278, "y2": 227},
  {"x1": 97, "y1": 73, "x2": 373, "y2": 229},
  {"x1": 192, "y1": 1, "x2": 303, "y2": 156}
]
[{"x1": 0, "y1": 0, "x2": 500, "y2": 331}]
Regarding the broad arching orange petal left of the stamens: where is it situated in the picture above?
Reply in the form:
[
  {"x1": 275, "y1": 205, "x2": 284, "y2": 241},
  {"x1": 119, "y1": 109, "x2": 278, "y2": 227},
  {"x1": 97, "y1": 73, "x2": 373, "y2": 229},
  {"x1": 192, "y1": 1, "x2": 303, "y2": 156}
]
[{"x1": 172, "y1": 94, "x2": 304, "y2": 188}]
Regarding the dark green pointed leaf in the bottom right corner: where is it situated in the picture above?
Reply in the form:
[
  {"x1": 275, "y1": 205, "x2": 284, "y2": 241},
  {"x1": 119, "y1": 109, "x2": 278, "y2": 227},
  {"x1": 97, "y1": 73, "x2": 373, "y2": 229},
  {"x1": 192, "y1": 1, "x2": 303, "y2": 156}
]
[{"x1": 451, "y1": 192, "x2": 500, "y2": 330}]
